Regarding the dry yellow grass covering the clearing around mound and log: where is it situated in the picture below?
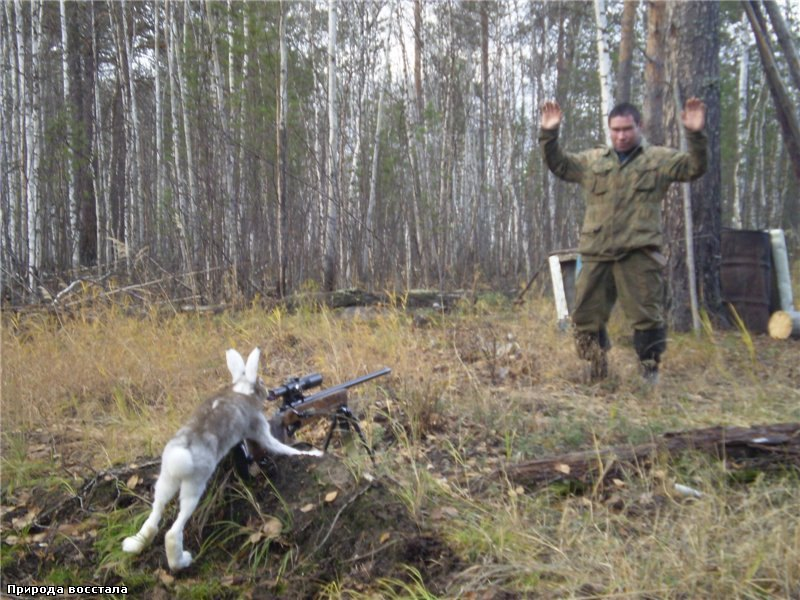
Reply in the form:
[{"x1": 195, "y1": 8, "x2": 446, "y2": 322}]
[{"x1": 2, "y1": 290, "x2": 800, "y2": 598}]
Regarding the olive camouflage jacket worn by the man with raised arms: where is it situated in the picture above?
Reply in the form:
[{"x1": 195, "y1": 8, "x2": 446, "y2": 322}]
[{"x1": 539, "y1": 129, "x2": 708, "y2": 260}]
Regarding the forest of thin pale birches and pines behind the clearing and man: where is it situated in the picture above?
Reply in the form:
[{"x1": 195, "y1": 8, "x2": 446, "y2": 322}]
[{"x1": 0, "y1": 0, "x2": 800, "y2": 323}]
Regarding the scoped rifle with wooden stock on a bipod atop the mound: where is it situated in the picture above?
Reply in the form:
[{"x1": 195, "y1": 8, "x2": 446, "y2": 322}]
[{"x1": 235, "y1": 367, "x2": 392, "y2": 474}]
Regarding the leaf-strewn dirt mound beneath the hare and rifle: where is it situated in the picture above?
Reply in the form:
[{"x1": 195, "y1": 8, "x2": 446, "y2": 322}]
[{"x1": 2, "y1": 455, "x2": 458, "y2": 598}]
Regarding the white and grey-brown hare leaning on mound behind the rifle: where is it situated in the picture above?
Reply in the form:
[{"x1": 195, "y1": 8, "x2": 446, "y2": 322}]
[{"x1": 122, "y1": 348, "x2": 322, "y2": 571}]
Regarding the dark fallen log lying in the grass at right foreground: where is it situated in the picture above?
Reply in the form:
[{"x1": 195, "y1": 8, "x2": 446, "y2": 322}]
[{"x1": 472, "y1": 423, "x2": 800, "y2": 489}]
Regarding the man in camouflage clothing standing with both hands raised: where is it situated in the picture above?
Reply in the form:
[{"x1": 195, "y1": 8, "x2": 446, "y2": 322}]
[{"x1": 539, "y1": 98, "x2": 708, "y2": 383}]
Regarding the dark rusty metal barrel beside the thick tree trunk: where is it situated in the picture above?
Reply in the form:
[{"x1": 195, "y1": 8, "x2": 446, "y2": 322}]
[{"x1": 720, "y1": 229, "x2": 772, "y2": 333}]
